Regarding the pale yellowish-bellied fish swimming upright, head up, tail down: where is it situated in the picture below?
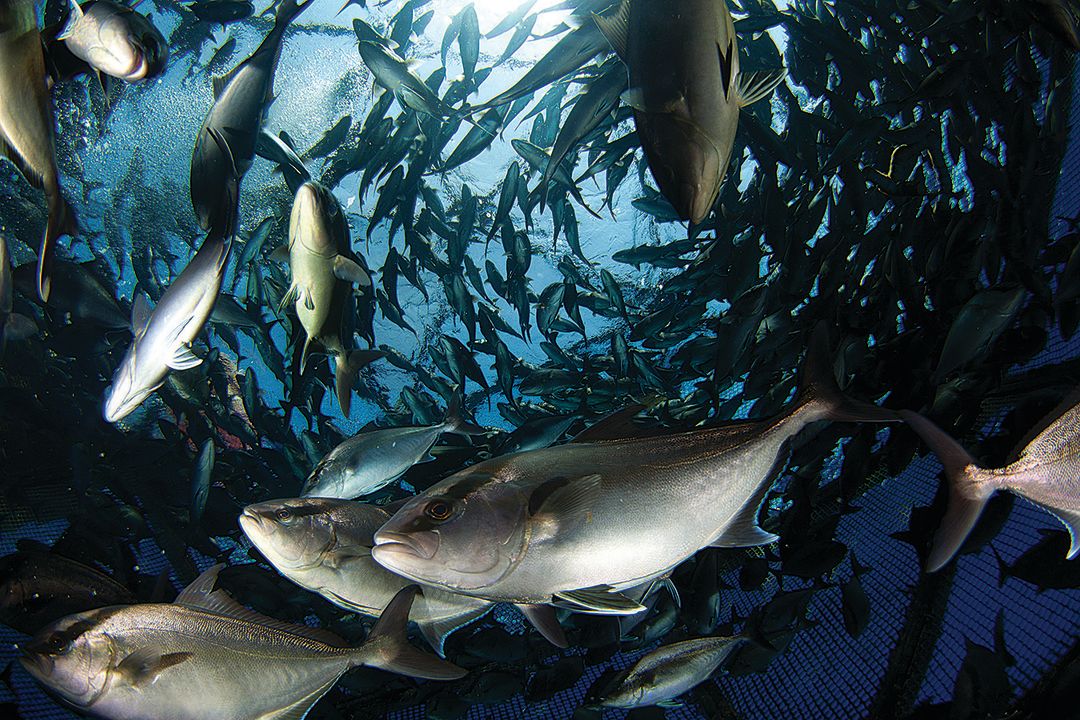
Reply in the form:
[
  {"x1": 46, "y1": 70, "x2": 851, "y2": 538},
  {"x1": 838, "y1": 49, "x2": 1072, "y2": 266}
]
[{"x1": 281, "y1": 181, "x2": 381, "y2": 417}]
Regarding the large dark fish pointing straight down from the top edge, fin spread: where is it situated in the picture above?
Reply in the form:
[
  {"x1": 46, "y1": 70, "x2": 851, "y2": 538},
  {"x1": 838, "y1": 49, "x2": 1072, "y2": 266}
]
[{"x1": 593, "y1": 0, "x2": 784, "y2": 225}]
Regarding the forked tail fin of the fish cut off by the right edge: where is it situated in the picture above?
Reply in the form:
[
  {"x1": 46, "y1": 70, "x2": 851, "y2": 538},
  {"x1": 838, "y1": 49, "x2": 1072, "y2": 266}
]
[{"x1": 900, "y1": 410, "x2": 997, "y2": 572}]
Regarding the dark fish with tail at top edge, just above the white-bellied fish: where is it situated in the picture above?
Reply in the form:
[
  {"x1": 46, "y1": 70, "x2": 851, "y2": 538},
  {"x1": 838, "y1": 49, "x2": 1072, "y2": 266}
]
[{"x1": 190, "y1": 0, "x2": 311, "y2": 234}]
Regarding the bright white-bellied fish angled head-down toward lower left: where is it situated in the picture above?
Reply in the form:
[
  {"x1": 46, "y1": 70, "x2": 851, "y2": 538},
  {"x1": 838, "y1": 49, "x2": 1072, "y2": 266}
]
[{"x1": 104, "y1": 235, "x2": 232, "y2": 423}]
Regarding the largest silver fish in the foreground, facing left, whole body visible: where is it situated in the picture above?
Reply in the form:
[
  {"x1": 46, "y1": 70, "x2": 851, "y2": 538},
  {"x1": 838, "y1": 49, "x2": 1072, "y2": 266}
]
[{"x1": 373, "y1": 331, "x2": 896, "y2": 614}]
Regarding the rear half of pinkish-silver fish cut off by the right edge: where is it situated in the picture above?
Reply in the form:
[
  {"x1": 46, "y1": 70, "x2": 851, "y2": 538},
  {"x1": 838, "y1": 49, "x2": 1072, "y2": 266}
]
[{"x1": 900, "y1": 403, "x2": 1080, "y2": 572}]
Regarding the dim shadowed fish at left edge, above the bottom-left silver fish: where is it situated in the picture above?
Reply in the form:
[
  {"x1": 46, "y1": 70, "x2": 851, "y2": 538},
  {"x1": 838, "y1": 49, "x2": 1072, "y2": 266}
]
[{"x1": 0, "y1": 545, "x2": 135, "y2": 635}]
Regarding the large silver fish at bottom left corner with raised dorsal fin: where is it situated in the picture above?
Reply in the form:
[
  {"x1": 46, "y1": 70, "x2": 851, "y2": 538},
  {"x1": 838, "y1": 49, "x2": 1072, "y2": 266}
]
[{"x1": 21, "y1": 566, "x2": 464, "y2": 720}]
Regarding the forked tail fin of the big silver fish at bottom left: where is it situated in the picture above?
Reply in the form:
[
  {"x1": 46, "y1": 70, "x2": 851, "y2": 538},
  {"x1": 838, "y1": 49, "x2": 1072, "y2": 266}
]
[{"x1": 356, "y1": 585, "x2": 465, "y2": 680}]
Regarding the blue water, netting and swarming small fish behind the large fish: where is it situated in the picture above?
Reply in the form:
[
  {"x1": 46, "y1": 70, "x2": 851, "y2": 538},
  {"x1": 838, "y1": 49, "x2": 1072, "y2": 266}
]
[{"x1": 0, "y1": 0, "x2": 1080, "y2": 719}]
